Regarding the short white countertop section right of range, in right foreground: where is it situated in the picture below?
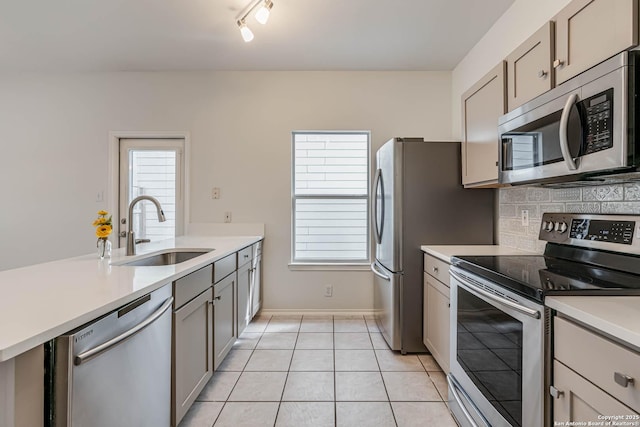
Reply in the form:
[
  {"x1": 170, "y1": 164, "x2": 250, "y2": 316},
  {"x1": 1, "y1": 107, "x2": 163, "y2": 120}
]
[{"x1": 545, "y1": 296, "x2": 640, "y2": 351}]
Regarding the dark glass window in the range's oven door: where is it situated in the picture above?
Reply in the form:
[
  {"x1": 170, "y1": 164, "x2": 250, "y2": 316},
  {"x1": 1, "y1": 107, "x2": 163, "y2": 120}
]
[{"x1": 456, "y1": 287, "x2": 523, "y2": 426}]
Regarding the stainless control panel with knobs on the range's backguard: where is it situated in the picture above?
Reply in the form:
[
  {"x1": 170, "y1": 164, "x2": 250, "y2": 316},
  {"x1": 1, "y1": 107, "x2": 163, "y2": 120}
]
[{"x1": 539, "y1": 213, "x2": 640, "y2": 253}]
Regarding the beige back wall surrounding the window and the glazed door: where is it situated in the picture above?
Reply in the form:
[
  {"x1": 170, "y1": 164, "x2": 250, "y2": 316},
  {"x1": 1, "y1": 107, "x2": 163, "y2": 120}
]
[{"x1": 0, "y1": 72, "x2": 452, "y2": 310}]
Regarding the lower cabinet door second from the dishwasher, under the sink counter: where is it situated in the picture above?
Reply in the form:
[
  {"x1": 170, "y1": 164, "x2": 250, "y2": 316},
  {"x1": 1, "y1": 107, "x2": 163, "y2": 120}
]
[{"x1": 213, "y1": 273, "x2": 238, "y2": 369}]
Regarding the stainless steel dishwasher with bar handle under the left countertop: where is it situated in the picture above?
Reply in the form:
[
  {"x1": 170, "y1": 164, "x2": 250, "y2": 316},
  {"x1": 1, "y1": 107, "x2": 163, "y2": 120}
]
[{"x1": 49, "y1": 285, "x2": 173, "y2": 427}]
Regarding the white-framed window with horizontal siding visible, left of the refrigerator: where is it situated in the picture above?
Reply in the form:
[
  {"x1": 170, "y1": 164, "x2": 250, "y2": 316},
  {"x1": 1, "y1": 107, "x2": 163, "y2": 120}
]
[{"x1": 292, "y1": 132, "x2": 369, "y2": 264}]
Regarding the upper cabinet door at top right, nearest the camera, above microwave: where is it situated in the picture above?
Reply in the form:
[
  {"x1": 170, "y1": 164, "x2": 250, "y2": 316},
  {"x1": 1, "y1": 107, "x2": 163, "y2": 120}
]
[{"x1": 553, "y1": 0, "x2": 638, "y2": 84}]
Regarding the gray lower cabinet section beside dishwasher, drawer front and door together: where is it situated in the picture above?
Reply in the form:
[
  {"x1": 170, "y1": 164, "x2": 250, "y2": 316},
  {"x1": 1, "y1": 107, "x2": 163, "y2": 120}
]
[{"x1": 171, "y1": 265, "x2": 213, "y2": 426}]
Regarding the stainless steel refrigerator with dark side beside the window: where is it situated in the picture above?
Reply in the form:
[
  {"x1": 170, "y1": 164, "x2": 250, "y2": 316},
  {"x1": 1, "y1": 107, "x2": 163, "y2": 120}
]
[{"x1": 371, "y1": 138, "x2": 495, "y2": 353}]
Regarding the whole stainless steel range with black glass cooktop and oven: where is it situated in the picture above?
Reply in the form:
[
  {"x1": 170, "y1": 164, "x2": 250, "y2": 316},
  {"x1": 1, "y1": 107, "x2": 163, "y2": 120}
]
[{"x1": 447, "y1": 213, "x2": 640, "y2": 427}]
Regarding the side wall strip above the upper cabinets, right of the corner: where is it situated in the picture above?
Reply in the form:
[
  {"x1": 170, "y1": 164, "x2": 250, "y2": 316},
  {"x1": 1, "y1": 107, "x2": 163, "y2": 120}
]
[{"x1": 451, "y1": 0, "x2": 571, "y2": 139}]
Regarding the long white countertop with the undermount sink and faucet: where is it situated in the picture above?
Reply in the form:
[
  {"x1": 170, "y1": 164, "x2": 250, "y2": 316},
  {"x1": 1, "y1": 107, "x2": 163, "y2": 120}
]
[{"x1": 0, "y1": 236, "x2": 262, "y2": 362}]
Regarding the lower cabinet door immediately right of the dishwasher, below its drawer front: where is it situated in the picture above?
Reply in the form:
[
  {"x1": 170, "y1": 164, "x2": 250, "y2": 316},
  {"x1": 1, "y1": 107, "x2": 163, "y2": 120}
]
[{"x1": 171, "y1": 289, "x2": 213, "y2": 426}]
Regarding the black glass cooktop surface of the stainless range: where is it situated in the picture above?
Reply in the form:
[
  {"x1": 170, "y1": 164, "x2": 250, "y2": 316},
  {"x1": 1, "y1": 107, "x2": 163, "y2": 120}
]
[{"x1": 453, "y1": 244, "x2": 640, "y2": 302}]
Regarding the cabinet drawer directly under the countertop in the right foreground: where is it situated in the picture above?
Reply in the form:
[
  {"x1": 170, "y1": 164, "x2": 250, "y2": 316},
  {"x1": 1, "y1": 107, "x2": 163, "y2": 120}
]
[{"x1": 554, "y1": 317, "x2": 640, "y2": 411}]
